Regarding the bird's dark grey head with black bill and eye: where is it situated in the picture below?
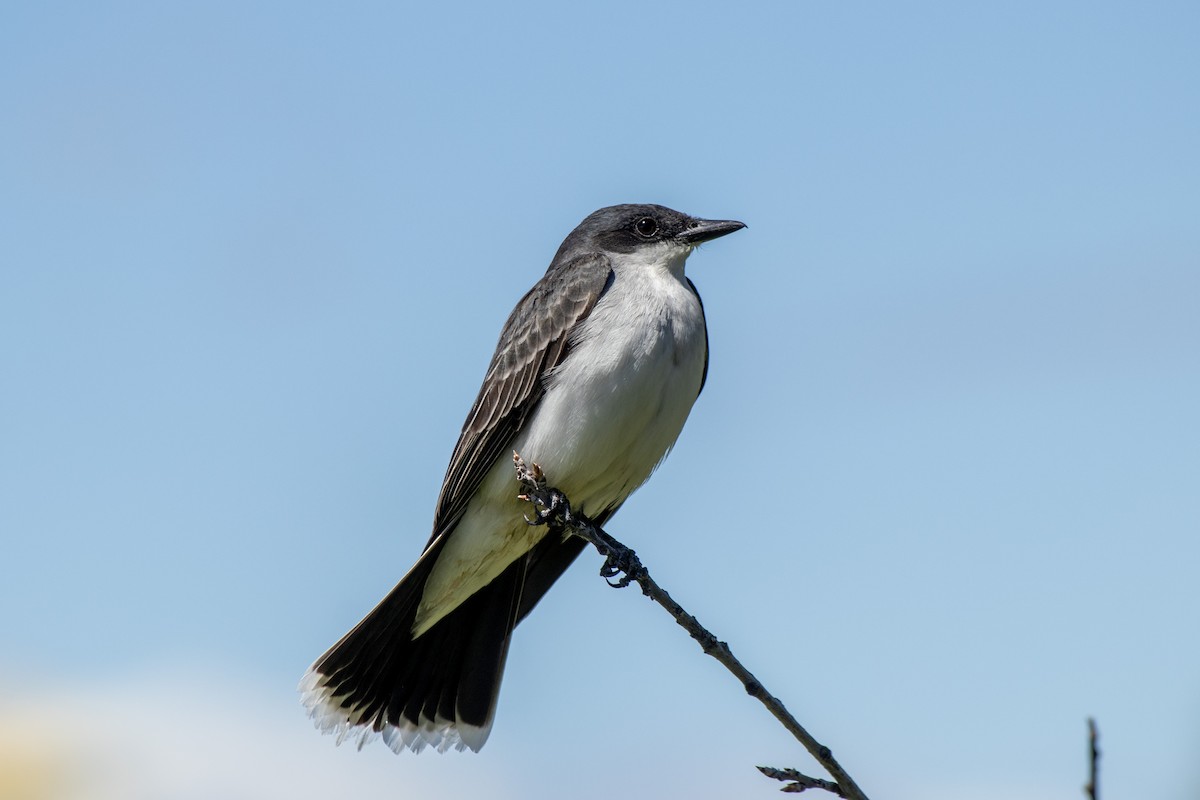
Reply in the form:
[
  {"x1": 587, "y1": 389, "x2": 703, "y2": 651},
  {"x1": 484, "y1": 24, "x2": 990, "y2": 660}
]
[{"x1": 554, "y1": 204, "x2": 745, "y2": 261}]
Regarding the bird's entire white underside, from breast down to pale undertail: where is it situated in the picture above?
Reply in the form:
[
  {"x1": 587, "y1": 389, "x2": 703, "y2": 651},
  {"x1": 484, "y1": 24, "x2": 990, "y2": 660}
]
[{"x1": 414, "y1": 263, "x2": 706, "y2": 634}]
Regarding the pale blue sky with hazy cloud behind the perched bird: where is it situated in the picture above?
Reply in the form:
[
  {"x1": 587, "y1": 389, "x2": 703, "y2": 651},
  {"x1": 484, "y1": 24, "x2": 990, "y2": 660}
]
[{"x1": 0, "y1": 2, "x2": 1200, "y2": 800}]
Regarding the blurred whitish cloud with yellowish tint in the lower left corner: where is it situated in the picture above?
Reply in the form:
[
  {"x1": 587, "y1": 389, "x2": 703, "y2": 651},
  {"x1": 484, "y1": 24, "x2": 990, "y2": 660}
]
[{"x1": 0, "y1": 672, "x2": 506, "y2": 800}]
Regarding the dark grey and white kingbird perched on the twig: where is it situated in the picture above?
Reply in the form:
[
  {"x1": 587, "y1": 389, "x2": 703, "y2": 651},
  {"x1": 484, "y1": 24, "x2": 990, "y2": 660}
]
[{"x1": 300, "y1": 205, "x2": 745, "y2": 752}]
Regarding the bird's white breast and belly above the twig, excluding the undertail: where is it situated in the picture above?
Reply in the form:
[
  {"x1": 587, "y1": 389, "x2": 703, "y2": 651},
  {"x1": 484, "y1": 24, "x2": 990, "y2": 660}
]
[{"x1": 518, "y1": 253, "x2": 706, "y2": 513}]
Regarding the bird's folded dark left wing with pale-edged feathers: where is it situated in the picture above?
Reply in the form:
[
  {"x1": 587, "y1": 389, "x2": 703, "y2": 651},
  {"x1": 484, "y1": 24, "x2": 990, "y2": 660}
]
[{"x1": 430, "y1": 254, "x2": 612, "y2": 545}]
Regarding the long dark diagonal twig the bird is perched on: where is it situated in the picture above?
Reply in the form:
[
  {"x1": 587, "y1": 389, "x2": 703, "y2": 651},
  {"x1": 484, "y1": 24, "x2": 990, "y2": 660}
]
[{"x1": 512, "y1": 452, "x2": 866, "y2": 800}]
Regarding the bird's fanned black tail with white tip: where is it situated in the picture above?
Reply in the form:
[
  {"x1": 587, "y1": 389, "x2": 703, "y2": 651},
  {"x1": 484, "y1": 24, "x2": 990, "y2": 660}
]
[{"x1": 300, "y1": 536, "x2": 582, "y2": 753}]
